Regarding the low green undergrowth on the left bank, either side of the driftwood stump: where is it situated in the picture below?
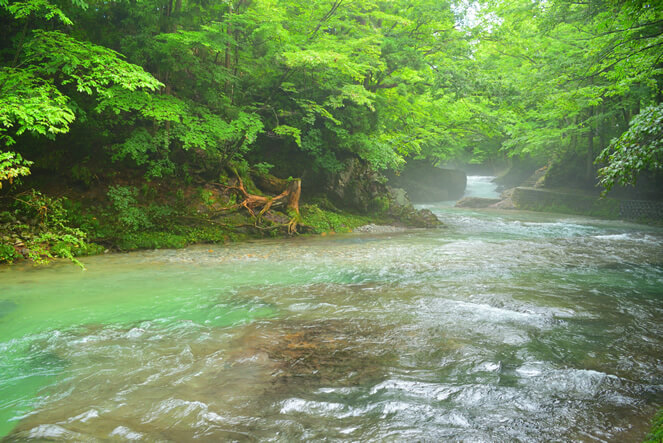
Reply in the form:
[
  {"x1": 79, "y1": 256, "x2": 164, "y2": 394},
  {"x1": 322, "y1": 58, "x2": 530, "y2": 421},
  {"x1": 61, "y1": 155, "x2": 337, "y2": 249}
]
[{"x1": 0, "y1": 186, "x2": 384, "y2": 267}]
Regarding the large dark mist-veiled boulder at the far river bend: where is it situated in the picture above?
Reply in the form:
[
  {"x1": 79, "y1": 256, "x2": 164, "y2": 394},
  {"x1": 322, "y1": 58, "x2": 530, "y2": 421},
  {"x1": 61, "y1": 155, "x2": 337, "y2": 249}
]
[{"x1": 388, "y1": 160, "x2": 467, "y2": 202}]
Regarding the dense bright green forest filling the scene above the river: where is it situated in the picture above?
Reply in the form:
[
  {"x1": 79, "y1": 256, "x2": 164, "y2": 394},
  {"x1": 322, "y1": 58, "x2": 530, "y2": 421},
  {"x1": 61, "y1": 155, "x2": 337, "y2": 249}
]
[{"x1": 0, "y1": 0, "x2": 663, "y2": 262}]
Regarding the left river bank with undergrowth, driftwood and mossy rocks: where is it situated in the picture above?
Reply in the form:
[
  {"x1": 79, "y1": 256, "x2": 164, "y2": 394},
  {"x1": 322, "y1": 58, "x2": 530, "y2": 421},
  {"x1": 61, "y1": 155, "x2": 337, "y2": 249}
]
[{"x1": 0, "y1": 168, "x2": 446, "y2": 266}]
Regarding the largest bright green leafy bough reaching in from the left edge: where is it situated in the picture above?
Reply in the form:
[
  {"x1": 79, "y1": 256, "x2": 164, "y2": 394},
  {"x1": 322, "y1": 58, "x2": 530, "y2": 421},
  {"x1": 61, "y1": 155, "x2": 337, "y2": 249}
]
[{"x1": 0, "y1": 29, "x2": 162, "y2": 144}]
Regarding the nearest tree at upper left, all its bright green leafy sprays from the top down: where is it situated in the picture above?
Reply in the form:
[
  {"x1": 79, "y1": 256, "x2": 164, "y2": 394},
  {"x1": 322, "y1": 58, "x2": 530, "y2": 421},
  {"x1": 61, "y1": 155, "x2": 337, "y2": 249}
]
[{"x1": 0, "y1": 0, "x2": 162, "y2": 186}]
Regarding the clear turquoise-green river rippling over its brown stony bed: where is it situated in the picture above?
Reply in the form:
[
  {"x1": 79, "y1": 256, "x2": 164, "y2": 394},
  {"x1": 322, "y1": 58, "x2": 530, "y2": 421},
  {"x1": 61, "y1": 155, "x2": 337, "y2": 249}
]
[{"x1": 0, "y1": 180, "x2": 663, "y2": 442}]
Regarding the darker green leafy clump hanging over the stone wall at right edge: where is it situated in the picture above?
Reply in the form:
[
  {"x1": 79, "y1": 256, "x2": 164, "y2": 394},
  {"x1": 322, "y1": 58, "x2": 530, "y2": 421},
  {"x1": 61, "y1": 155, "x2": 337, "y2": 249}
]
[{"x1": 597, "y1": 103, "x2": 663, "y2": 195}]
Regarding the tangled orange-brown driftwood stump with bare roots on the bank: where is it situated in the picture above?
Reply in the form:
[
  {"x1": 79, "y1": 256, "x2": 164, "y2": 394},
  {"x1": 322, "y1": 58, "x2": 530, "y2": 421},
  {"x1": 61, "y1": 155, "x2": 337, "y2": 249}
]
[{"x1": 215, "y1": 175, "x2": 302, "y2": 234}]
